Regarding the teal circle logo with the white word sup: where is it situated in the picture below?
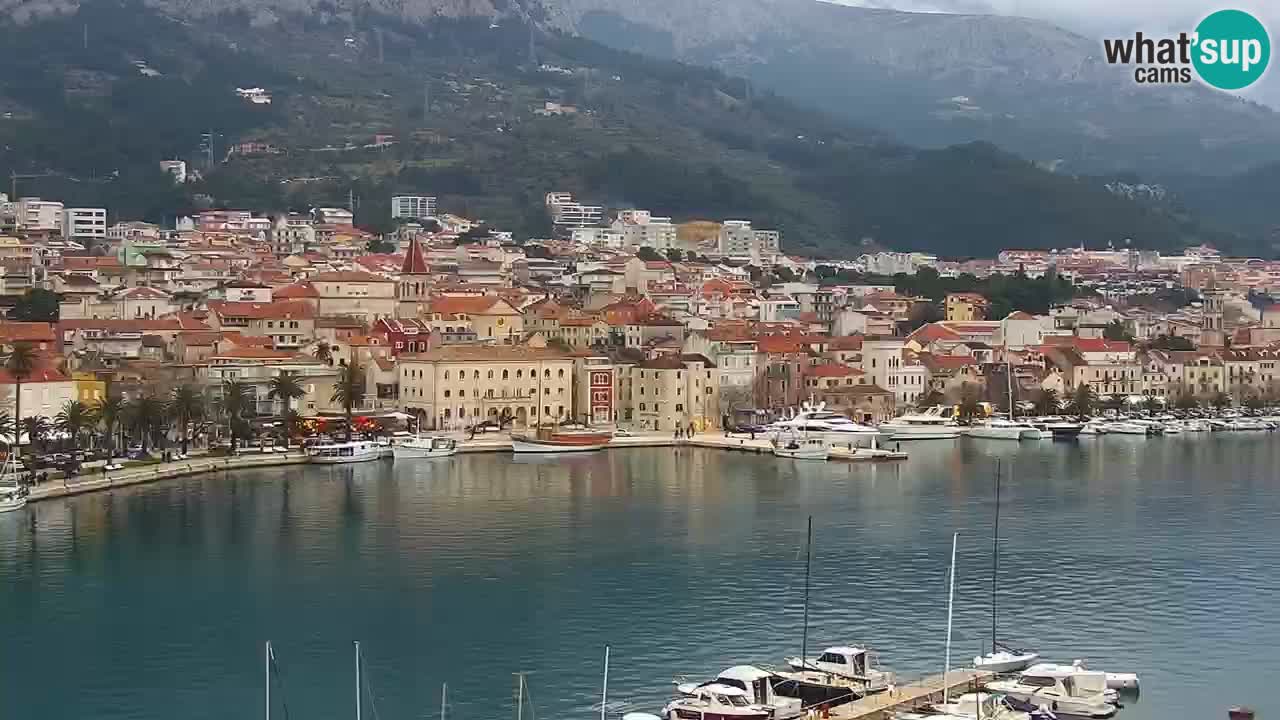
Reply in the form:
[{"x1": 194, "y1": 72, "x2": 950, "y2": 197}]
[{"x1": 1192, "y1": 10, "x2": 1271, "y2": 90}]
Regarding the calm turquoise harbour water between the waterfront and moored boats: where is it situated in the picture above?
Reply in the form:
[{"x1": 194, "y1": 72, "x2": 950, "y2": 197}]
[{"x1": 0, "y1": 434, "x2": 1280, "y2": 720}]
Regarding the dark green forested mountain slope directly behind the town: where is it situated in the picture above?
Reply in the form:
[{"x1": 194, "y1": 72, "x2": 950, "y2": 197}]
[{"x1": 0, "y1": 0, "x2": 1236, "y2": 256}]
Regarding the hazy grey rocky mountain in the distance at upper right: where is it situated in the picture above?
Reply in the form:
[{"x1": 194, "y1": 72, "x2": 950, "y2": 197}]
[{"x1": 545, "y1": 0, "x2": 1280, "y2": 176}]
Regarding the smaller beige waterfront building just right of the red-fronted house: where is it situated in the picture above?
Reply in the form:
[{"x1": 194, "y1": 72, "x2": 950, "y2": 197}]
[{"x1": 631, "y1": 355, "x2": 721, "y2": 432}]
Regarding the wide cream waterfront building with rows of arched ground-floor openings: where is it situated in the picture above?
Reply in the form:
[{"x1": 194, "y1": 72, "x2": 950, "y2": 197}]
[{"x1": 398, "y1": 343, "x2": 575, "y2": 429}]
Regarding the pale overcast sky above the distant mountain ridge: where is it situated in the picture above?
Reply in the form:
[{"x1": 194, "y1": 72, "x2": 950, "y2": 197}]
[{"x1": 835, "y1": 0, "x2": 1280, "y2": 109}]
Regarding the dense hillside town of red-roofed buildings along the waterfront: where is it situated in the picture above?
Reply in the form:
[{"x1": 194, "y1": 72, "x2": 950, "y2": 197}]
[{"x1": 0, "y1": 183, "x2": 1280, "y2": 452}]
